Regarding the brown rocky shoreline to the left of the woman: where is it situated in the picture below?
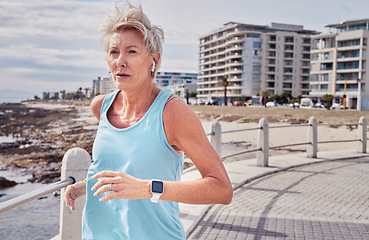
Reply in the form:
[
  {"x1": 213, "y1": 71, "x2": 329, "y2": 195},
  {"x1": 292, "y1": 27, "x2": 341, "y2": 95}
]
[{"x1": 0, "y1": 102, "x2": 97, "y2": 189}]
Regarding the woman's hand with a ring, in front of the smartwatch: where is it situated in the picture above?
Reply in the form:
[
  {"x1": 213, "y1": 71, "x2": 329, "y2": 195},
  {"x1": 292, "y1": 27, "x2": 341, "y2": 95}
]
[{"x1": 91, "y1": 171, "x2": 151, "y2": 201}]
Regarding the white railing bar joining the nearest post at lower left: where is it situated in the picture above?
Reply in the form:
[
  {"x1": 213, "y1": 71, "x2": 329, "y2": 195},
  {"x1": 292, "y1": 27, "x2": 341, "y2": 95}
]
[{"x1": 0, "y1": 177, "x2": 75, "y2": 214}]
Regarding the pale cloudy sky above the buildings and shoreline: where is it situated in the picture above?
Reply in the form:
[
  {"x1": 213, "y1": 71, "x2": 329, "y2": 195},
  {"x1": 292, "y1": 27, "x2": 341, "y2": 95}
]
[{"x1": 0, "y1": 0, "x2": 369, "y2": 97}]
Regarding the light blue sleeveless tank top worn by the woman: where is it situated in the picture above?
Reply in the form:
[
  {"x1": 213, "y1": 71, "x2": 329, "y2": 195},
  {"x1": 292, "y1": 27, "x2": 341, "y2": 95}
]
[{"x1": 82, "y1": 90, "x2": 186, "y2": 240}]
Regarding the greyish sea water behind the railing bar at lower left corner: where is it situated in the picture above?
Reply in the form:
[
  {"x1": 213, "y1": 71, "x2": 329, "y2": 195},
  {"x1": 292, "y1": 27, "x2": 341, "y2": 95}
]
[{"x1": 0, "y1": 170, "x2": 60, "y2": 240}]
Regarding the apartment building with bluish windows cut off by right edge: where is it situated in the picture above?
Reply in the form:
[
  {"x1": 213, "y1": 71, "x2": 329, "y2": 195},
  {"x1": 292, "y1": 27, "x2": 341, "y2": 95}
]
[{"x1": 310, "y1": 19, "x2": 369, "y2": 110}]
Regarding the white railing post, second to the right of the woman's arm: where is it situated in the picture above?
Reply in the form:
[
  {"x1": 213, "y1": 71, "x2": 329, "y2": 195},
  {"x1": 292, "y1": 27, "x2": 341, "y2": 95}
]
[{"x1": 256, "y1": 118, "x2": 269, "y2": 167}]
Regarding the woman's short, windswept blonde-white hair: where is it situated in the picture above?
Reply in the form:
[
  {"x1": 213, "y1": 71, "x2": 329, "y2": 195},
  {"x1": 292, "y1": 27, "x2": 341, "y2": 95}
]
[{"x1": 100, "y1": 1, "x2": 164, "y2": 76}]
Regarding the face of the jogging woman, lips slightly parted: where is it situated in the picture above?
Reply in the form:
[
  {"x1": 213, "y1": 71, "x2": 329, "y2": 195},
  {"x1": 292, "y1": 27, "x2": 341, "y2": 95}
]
[{"x1": 106, "y1": 30, "x2": 154, "y2": 91}]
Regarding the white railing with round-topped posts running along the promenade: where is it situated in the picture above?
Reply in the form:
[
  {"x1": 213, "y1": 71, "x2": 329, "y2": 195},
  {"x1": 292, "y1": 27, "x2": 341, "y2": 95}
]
[{"x1": 0, "y1": 117, "x2": 367, "y2": 239}]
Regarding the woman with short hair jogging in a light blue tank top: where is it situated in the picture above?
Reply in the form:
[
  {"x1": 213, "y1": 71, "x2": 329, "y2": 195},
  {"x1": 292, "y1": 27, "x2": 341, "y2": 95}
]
[{"x1": 65, "y1": 3, "x2": 233, "y2": 239}]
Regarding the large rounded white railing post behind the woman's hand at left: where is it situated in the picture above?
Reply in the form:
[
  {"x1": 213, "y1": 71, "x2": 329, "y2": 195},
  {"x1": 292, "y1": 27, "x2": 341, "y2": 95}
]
[{"x1": 59, "y1": 148, "x2": 91, "y2": 240}]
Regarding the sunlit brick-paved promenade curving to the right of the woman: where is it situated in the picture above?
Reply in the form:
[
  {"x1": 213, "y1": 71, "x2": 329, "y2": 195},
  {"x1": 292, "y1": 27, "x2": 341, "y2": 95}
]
[{"x1": 182, "y1": 152, "x2": 369, "y2": 239}]
